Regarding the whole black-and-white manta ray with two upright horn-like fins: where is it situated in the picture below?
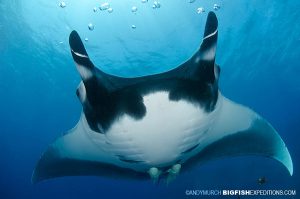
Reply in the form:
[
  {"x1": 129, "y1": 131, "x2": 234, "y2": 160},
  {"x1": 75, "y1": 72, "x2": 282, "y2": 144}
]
[{"x1": 32, "y1": 12, "x2": 293, "y2": 183}]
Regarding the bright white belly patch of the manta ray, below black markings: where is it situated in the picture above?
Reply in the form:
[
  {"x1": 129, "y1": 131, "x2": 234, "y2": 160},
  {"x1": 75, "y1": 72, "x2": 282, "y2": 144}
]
[{"x1": 84, "y1": 92, "x2": 215, "y2": 170}]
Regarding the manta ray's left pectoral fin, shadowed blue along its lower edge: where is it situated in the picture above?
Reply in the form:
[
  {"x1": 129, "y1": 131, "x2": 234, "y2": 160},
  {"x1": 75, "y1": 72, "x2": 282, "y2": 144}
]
[{"x1": 31, "y1": 115, "x2": 149, "y2": 183}]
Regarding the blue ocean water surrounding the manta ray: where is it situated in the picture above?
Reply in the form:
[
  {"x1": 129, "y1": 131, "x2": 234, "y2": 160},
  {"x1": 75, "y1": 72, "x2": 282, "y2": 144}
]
[{"x1": 0, "y1": 0, "x2": 300, "y2": 199}]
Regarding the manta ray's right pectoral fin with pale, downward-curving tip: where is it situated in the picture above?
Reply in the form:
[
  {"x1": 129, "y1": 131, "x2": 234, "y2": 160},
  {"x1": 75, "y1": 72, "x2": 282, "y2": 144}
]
[{"x1": 185, "y1": 95, "x2": 293, "y2": 175}]
